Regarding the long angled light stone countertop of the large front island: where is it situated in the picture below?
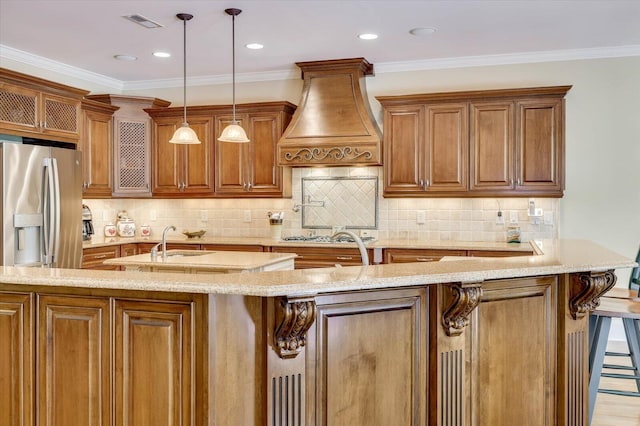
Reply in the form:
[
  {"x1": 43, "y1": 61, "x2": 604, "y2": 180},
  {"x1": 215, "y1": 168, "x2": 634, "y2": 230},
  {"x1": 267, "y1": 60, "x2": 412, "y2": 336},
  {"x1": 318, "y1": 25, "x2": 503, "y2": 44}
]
[{"x1": 0, "y1": 240, "x2": 636, "y2": 297}]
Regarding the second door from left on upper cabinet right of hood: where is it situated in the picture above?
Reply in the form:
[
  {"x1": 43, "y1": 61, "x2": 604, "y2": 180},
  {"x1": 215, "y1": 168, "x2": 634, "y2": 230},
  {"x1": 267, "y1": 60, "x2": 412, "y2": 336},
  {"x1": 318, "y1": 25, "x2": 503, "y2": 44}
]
[{"x1": 426, "y1": 104, "x2": 469, "y2": 192}]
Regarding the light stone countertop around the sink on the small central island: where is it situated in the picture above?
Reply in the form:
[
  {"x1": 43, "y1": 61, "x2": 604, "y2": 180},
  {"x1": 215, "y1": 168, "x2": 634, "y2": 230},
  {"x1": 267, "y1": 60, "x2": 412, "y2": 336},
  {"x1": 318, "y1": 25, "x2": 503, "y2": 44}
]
[{"x1": 104, "y1": 250, "x2": 296, "y2": 272}]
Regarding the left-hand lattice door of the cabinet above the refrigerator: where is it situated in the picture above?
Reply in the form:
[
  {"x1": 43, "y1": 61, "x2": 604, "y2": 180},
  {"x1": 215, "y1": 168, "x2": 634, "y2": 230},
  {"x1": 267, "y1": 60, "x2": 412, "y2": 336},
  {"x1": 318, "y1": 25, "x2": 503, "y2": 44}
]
[{"x1": 0, "y1": 83, "x2": 40, "y2": 133}]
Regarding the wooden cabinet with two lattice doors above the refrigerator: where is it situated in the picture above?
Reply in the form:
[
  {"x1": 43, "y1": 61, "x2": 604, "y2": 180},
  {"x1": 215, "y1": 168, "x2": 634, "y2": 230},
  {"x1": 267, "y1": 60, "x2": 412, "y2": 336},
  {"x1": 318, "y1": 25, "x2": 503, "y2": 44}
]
[{"x1": 0, "y1": 68, "x2": 89, "y2": 144}]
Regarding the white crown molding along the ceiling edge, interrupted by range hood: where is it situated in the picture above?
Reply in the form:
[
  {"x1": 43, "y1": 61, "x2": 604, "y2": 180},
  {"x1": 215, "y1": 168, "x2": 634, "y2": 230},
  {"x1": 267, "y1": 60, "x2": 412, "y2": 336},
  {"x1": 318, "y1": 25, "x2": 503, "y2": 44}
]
[{"x1": 0, "y1": 44, "x2": 640, "y2": 93}]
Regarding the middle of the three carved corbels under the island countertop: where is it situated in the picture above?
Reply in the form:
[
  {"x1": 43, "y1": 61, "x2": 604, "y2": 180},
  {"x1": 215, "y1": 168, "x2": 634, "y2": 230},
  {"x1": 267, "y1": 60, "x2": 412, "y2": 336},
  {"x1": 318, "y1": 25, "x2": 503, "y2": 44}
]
[{"x1": 442, "y1": 282, "x2": 482, "y2": 336}]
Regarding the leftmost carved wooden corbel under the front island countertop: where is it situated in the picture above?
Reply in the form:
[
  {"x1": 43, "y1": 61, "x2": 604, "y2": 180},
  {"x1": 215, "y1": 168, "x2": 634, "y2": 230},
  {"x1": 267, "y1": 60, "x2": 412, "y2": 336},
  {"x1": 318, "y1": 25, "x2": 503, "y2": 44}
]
[{"x1": 273, "y1": 297, "x2": 316, "y2": 359}]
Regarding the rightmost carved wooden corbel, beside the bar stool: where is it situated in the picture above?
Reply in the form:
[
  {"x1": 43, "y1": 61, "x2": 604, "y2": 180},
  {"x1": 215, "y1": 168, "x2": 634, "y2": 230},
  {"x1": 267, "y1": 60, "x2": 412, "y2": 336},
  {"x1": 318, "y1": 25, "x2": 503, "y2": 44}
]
[{"x1": 569, "y1": 269, "x2": 617, "y2": 319}]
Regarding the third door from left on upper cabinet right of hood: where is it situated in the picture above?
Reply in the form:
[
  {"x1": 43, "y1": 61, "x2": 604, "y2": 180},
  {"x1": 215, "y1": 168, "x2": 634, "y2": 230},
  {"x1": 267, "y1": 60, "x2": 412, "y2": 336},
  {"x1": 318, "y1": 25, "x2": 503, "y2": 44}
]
[{"x1": 470, "y1": 102, "x2": 515, "y2": 190}]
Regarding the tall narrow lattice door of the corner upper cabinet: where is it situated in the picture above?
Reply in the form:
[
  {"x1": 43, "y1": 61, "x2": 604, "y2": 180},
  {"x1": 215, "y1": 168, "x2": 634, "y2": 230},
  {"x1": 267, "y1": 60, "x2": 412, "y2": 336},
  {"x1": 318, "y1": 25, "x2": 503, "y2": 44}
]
[{"x1": 113, "y1": 119, "x2": 151, "y2": 197}]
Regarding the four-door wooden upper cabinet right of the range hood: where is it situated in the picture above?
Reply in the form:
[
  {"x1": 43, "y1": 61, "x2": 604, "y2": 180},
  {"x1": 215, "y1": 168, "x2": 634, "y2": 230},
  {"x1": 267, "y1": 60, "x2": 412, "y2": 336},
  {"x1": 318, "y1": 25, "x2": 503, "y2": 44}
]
[{"x1": 377, "y1": 86, "x2": 571, "y2": 197}]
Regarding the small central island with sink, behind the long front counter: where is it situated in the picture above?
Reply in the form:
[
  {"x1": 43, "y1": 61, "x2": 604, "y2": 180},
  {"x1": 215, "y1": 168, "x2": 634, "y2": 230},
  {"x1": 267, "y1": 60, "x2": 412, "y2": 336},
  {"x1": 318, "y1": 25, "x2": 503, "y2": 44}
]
[{"x1": 104, "y1": 250, "x2": 296, "y2": 274}]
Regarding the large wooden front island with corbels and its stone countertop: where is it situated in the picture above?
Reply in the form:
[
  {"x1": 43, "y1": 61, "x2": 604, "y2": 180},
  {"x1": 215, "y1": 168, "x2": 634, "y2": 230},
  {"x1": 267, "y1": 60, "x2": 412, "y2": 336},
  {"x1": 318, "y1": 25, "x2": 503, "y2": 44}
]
[{"x1": 0, "y1": 240, "x2": 635, "y2": 425}]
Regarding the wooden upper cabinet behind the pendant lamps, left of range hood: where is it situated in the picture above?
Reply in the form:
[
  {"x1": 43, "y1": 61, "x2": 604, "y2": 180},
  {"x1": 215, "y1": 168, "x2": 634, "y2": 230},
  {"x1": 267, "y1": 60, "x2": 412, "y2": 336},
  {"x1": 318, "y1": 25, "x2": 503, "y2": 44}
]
[{"x1": 146, "y1": 102, "x2": 295, "y2": 198}]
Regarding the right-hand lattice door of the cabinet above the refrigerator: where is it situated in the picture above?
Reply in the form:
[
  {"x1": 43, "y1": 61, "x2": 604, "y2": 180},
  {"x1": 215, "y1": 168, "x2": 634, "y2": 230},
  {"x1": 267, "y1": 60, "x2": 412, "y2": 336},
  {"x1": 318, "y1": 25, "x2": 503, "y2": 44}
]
[{"x1": 40, "y1": 93, "x2": 80, "y2": 137}]
